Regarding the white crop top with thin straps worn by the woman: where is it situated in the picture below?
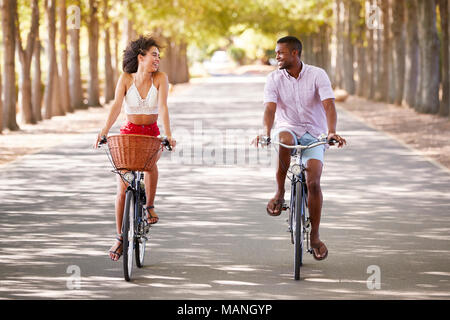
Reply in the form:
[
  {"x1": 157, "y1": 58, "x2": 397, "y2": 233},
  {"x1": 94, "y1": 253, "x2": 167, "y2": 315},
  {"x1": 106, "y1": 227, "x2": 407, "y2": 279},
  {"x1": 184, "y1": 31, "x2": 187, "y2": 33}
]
[{"x1": 122, "y1": 76, "x2": 158, "y2": 114}]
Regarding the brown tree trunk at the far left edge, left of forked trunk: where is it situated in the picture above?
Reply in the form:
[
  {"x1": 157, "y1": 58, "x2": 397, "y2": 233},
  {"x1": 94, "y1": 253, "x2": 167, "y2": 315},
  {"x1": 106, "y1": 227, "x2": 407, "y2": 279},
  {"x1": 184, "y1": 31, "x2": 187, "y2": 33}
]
[{"x1": 2, "y1": 0, "x2": 19, "y2": 131}]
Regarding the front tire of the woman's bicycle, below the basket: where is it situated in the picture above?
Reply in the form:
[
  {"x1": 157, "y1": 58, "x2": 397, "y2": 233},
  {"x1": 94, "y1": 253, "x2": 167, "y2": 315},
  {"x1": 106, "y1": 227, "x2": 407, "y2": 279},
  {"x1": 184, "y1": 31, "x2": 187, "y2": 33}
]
[{"x1": 122, "y1": 190, "x2": 135, "y2": 281}]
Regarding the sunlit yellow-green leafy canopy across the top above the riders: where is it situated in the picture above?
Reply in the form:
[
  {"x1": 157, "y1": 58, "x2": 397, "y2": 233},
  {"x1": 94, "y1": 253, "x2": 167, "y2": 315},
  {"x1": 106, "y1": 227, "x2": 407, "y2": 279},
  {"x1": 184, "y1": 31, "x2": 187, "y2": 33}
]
[{"x1": 13, "y1": 0, "x2": 334, "y2": 61}]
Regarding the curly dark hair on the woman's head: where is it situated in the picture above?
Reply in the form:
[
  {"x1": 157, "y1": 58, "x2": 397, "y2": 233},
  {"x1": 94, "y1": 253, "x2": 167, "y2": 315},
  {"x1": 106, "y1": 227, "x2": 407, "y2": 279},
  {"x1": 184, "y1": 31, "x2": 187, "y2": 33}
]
[{"x1": 122, "y1": 35, "x2": 161, "y2": 73}]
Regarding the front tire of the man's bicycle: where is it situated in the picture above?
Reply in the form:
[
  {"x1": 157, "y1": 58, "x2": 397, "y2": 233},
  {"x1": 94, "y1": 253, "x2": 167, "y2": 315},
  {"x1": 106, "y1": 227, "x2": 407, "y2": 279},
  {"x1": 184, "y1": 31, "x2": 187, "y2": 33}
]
[{"x1": 293, "y1": 181, "x2": 304, "y2": 280}]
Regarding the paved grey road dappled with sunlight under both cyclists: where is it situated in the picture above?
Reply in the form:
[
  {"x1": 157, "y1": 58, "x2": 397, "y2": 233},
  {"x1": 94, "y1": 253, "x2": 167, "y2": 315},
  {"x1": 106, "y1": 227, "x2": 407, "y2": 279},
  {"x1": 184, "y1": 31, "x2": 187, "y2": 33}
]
[{"x1": 0, "y1": 77, "x2": 450, "y2": 299}]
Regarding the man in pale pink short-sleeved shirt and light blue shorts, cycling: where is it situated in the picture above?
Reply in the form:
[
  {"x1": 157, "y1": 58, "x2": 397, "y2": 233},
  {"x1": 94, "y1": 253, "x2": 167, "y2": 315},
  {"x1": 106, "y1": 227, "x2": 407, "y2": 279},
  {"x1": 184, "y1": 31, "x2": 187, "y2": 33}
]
[{"x1": 255, "y1": 36, "x2": 346, "y2": 260}]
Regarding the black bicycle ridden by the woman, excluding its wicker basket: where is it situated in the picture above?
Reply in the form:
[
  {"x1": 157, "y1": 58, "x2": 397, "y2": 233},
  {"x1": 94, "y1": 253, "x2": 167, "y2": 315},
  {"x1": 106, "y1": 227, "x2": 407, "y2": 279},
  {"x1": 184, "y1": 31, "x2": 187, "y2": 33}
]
[{"x1": 99, "y1": 136, "x2": 172, "y2": 281}]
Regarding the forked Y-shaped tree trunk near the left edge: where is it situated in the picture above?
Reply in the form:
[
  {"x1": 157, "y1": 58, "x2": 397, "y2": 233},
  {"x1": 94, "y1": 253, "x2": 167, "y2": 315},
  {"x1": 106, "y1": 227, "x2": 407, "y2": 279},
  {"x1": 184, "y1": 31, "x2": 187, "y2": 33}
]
[{"x1": 15, "y1": 0, "x2": 39, "y2": 124}]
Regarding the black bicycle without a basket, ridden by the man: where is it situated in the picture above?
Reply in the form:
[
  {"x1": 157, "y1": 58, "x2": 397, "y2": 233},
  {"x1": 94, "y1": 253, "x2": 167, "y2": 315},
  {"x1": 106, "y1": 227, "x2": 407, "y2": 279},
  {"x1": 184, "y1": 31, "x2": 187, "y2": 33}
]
[{"x1": 262, "y1": 135, "x2": 337, "y2": 280}]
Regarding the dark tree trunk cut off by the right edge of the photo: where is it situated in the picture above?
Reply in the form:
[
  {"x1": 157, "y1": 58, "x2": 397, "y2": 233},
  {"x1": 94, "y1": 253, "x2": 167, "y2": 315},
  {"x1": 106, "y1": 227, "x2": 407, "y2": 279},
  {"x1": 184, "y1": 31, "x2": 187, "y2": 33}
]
[{"x1": 439, "y1": 0, "x2": 450, "y2": 116}]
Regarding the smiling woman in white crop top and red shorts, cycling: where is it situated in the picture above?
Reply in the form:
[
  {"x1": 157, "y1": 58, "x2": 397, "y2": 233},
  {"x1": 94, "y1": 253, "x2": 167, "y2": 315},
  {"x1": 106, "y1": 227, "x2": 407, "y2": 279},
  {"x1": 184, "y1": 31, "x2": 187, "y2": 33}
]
[{"x1": 95, "y1": 36, "x2": 176, "y2": 261}]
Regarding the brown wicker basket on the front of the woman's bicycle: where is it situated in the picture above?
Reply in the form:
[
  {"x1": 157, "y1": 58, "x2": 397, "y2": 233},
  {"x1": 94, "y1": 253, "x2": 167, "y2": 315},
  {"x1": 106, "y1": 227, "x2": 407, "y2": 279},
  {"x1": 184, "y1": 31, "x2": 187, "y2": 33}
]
[{"x1": 108, "y1": 134, "x2": 161, "y2": 171}]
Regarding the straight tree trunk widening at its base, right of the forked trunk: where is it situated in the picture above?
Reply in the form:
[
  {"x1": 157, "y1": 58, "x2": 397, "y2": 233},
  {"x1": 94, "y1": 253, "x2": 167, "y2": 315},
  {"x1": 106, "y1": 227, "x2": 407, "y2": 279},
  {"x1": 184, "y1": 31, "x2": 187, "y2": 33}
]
[{"x1": 44, "y1": 0, "x2": 64, "y2": 119}]
